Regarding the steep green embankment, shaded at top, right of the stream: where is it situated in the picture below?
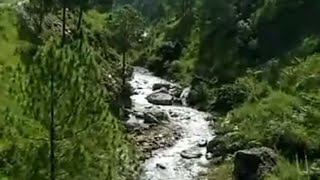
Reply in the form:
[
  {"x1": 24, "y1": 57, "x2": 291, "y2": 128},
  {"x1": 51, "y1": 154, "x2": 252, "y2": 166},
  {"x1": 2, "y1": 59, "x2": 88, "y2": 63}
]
[{"x1": 132, "y1": 0, "x2": 320, "y2": 179}]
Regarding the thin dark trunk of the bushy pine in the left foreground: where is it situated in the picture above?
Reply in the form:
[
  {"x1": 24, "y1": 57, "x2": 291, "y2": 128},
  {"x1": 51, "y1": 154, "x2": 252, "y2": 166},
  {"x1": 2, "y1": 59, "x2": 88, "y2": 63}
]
[{"x1": 50, "y1": 72, "x2": 56, "y2": 180}]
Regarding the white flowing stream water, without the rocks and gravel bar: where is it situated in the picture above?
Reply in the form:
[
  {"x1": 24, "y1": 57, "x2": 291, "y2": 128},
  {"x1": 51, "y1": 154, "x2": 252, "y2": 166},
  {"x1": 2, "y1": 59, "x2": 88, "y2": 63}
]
[{"x1": 130, "y1": 68, "x2": 212, "y2": 180}]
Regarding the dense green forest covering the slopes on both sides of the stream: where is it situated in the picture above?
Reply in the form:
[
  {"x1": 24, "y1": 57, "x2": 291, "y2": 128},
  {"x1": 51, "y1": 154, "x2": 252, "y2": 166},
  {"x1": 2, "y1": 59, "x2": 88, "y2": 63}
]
[{"x1": 0, "y1": 0, "x2": 320, "y2": 180}]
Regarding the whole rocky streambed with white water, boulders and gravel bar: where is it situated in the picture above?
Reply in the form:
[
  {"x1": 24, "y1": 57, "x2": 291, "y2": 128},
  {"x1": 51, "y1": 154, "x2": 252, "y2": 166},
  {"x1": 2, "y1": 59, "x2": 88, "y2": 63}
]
[{"x1": 126, "y1": 68, "x2": 213, "y2": 180}]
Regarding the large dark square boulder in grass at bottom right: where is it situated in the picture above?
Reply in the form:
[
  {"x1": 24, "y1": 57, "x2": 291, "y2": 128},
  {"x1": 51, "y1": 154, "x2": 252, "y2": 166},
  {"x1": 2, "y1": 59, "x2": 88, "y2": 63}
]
[{"x1": 233, "y1": 147, "x2": 278, "y2": 180}]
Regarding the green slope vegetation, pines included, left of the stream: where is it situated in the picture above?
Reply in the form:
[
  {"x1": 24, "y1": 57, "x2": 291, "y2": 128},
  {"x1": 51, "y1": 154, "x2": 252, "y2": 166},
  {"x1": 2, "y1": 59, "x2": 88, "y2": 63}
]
[{"x1": 0, "y1": 1, "x2": 144, "y2": 180}]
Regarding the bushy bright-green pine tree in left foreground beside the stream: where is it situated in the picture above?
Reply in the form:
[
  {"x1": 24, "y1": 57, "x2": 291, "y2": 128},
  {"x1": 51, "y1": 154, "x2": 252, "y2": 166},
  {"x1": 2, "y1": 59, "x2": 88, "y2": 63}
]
[{"x1": 7, "y1": 35, "x2": 136, "y2": 180}]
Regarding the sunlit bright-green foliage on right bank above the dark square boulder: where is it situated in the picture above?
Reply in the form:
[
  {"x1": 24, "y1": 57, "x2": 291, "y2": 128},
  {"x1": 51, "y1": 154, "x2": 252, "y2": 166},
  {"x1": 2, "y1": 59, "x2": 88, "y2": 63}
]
[{"x1": 221, "y1": 55, "x2": 320, "y2": 159}]
